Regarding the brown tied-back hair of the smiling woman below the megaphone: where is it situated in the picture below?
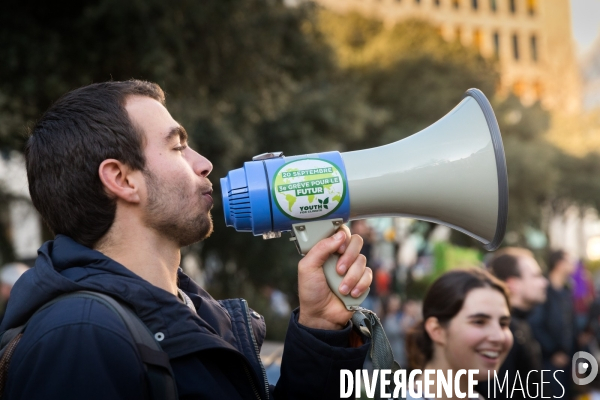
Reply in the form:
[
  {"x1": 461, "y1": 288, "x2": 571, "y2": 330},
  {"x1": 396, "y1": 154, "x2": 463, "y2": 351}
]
[{"x1": 406, "y1": 268, "x2": 510, "y2": 369}]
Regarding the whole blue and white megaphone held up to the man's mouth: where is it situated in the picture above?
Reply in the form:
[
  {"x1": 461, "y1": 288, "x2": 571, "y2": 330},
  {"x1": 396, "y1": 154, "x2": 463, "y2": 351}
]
[{"x1": 221, "y1": 89, "x2": 508, "y2": 310}]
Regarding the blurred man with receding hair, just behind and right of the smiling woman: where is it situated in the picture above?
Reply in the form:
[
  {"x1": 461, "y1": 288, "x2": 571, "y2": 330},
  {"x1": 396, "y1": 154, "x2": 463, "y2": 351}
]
[{"x1": 479, "y1": 247, "x2": 548, "y2": 399}]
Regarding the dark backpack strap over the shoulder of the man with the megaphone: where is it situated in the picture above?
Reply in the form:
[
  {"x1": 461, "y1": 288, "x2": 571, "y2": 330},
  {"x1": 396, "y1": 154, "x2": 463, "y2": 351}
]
[{"x1": 0, "y1": 290, "x2": 177, "y2": 400}]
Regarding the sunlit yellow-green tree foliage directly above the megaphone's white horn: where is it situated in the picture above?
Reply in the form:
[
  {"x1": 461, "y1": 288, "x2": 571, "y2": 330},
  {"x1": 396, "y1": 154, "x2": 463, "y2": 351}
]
[{"x1": 319, "y1": 10, "x2": 498, "y2": 149}]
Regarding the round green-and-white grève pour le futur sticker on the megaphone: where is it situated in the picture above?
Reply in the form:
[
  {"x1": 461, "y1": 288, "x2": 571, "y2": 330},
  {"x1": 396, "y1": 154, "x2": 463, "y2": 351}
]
[{"x1": 271, "y1": 158, "x2": 346, "y2": 219}]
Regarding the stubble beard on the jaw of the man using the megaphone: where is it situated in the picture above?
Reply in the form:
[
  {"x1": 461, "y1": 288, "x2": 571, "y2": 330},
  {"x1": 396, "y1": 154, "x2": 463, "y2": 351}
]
[{"x1": 142, "y1": 169, "x2": 213, "y2": 247}]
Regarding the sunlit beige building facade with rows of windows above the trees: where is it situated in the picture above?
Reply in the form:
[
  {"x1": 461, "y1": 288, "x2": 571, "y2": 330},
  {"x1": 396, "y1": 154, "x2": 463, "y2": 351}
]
[{"x1": 314, "y1": 0, "x2": 582, "y2": 113}]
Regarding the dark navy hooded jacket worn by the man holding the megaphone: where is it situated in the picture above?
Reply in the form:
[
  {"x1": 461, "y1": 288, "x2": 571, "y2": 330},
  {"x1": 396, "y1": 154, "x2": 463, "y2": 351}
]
[{"x1": 0, "y1": 235, "x2": 368, "y2": 400}]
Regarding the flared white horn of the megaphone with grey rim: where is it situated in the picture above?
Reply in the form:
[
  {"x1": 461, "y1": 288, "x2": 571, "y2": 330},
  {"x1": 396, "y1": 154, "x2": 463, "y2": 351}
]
[{"x1": 341, "y1": 89, "x2": 508, "y2": 251}]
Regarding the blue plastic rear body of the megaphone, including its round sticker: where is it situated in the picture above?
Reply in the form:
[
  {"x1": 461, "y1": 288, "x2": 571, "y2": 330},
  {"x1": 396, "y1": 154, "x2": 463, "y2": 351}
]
[{"x1": 221, "y1": 152, "x2": 350, "y2": 238}]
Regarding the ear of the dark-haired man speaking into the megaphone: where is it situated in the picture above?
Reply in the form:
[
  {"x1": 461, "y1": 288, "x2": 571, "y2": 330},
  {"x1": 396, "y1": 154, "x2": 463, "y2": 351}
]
[{"x1": 98, "y1": 158, "x2": 141, "y2": 203}]
